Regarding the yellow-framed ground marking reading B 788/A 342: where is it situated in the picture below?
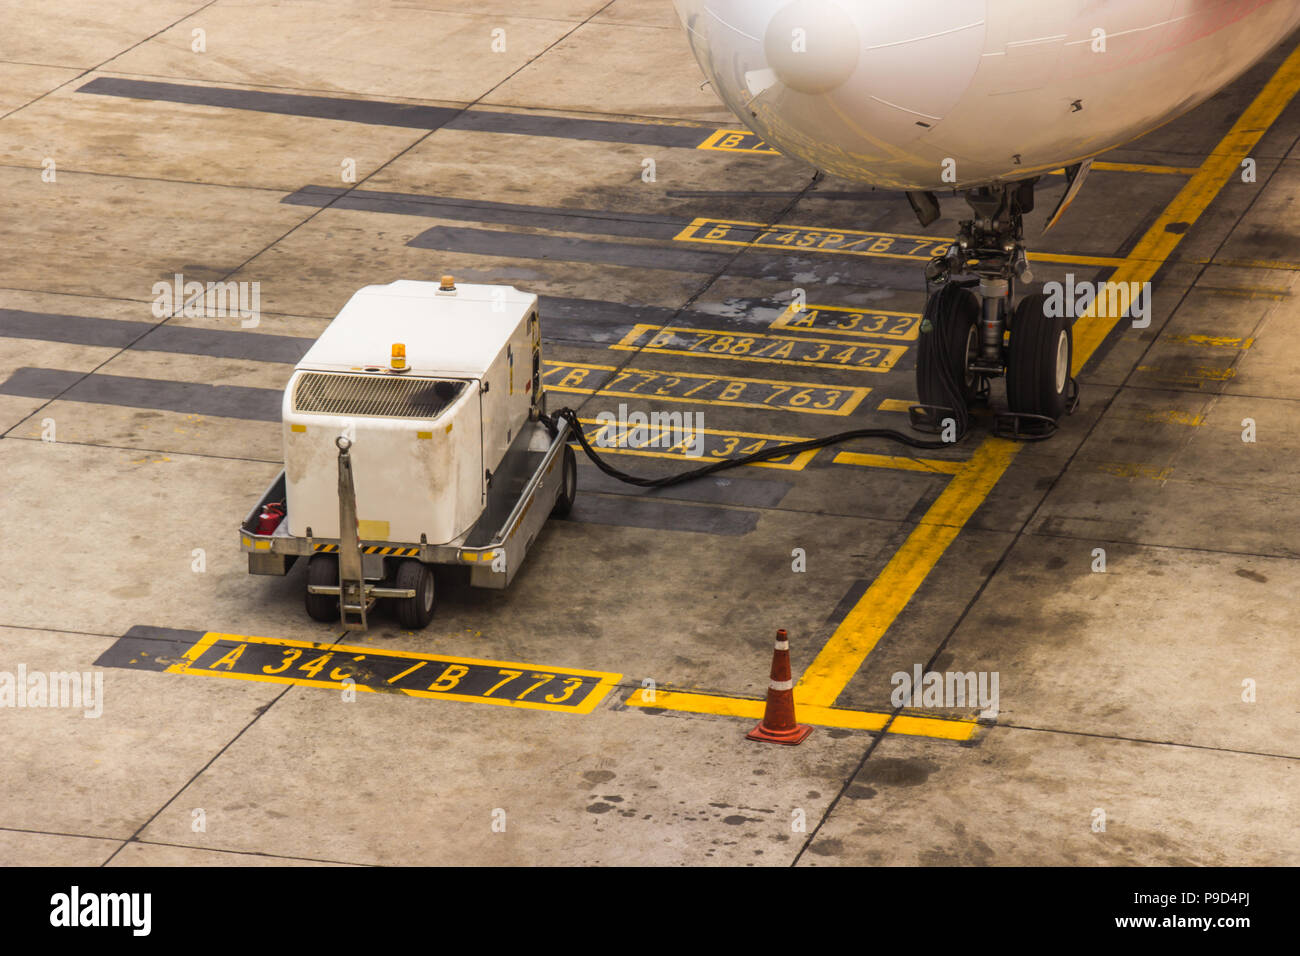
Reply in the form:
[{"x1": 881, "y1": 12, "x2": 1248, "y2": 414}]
[{"x1": 610, "y1": 325, "x2": 907, "y2": 372}]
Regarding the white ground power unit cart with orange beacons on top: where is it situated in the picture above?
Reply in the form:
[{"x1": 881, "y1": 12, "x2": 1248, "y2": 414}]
[{"x1": 239, "y1": 276, "x2": 577, "y2": 630}]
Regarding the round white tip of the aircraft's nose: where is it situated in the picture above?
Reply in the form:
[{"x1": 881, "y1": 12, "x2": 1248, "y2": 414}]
[{"x1": 763, "y1": 0, "x2": 861, "y2": 94}]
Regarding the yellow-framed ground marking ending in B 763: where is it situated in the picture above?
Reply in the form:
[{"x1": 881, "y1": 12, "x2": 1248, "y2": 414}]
[{"x1": 542, "y1": 362, "x2": 871, "y2": 415}]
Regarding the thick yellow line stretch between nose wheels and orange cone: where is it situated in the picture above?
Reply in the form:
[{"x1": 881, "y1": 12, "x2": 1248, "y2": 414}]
[{"x1": 794, "y1": 438, "x2": 1021, "y2": 706}]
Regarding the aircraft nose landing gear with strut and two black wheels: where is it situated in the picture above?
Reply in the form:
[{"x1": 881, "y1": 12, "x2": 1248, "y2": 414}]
[{"x1": 911, "y1": 178, "x2": 1079, "y2": 440}]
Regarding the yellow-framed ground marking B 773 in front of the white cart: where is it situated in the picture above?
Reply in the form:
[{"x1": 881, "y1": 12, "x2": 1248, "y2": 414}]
[{"x1": 166, "y1": 631, "x2": 623, "y2": 714}]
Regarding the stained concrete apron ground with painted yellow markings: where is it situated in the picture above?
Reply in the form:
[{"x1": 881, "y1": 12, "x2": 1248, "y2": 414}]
[{"x1": 0, "y1": 0, "x2": 1300, "y2": 866}]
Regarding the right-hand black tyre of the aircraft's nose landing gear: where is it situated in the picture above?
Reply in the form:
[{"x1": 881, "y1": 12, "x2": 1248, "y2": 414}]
[{"x1": 1006, "y1": 293, "x2": 1074, "y2": 420}]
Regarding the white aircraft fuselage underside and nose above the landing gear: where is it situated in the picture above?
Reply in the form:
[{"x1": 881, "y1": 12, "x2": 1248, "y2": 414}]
[{"x1": 673, "y1": 0, "x2": 1300, "y2": 190}]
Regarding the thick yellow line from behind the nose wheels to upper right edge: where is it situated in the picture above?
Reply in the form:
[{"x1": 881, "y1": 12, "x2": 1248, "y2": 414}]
[{"x1": 1073, "y1": 40, "x2": 1300, "y2": 375}]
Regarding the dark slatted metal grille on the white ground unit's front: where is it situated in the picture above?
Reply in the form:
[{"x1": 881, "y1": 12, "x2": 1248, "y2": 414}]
[{"x1": 294, "y1": 372, "x2": 465, "y2": 419}]
